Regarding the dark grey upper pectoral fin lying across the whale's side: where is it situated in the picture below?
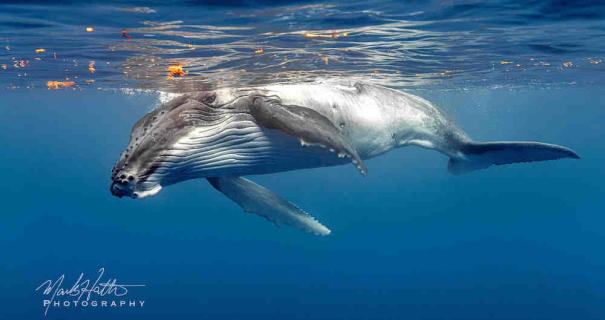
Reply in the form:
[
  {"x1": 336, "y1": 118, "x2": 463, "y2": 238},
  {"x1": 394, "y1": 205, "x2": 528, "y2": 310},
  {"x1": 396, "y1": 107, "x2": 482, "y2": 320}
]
[{"x1": 250, "y1": 96, "x2": 368, "y2": 176}]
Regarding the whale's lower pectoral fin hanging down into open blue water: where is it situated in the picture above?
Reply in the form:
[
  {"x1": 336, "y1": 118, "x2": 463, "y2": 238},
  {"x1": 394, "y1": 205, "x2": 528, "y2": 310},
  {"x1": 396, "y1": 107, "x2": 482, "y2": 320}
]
[{"x1": 208, "y1": 177, "x2": 330, "y2": 236}]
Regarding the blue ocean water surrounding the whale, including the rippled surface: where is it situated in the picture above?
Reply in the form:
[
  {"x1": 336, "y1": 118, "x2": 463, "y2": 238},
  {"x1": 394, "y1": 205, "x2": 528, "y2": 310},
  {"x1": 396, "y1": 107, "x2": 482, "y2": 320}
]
[{"x1": 0, "y1": 0, "x2": 605, "y2": 320}]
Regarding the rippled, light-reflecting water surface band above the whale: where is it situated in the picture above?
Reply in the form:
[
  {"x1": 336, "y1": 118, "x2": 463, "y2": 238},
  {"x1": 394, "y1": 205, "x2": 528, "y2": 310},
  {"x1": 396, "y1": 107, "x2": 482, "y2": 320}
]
[{"x1": 0, "y1": 1, "x2": 605, "y2": 91}]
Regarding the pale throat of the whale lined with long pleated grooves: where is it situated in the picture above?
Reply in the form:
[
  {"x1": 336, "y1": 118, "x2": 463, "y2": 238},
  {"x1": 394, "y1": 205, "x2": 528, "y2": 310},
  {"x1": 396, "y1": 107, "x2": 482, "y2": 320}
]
[{"x1": 143, "y1": 114, "x2": 349, "y2": 185}]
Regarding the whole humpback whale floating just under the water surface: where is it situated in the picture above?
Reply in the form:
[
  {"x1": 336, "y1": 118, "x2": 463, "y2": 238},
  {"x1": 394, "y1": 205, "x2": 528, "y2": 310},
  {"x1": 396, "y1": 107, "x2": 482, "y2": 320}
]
[{"x1": 110, "y1": 82, "x2": 579, "y2": 235}]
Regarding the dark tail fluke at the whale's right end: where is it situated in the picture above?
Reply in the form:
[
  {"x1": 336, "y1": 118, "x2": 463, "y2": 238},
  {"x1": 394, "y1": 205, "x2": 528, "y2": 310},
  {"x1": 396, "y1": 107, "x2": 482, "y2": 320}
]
[{"x1": 447, "y1": 141, "x2": 580, "y2": 174}]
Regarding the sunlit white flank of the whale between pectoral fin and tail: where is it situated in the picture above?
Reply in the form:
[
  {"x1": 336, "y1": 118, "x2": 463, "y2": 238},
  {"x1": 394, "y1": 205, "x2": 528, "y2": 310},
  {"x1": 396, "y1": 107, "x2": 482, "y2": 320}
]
[{"x1": 250, "y1": 82, "x2": 468, "y2": 159}]
